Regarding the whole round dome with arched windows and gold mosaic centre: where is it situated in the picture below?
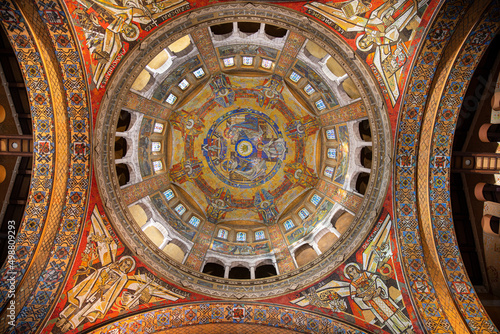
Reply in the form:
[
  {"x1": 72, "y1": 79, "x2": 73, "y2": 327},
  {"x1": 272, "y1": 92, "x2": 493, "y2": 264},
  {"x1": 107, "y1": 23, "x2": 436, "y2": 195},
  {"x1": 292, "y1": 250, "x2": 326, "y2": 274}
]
[{"x1": 95, "y1": 4, "x2": 390, "y2": 299}]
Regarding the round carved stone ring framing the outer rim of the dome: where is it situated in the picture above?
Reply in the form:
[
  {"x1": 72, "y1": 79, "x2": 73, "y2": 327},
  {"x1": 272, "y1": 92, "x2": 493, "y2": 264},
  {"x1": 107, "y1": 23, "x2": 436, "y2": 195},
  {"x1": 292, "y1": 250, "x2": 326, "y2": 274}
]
[{"x1": 95, "y1": 3, "x2": 391, "y2": 299}]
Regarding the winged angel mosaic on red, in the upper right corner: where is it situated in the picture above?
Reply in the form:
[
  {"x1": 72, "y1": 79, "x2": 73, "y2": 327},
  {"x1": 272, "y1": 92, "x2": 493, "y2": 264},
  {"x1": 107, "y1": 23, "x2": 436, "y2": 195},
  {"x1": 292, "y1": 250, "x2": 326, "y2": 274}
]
[{"x1": 306, "y1": 0, "x2": 428, "y2": 106}]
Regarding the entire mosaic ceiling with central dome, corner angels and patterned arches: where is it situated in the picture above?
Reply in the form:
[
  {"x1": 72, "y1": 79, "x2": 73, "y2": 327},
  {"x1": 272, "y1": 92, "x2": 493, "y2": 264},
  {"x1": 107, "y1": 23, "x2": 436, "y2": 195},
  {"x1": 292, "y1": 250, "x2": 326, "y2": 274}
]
[{"x1": 0, "y1": 0, "x2": 500, "y2": 334}]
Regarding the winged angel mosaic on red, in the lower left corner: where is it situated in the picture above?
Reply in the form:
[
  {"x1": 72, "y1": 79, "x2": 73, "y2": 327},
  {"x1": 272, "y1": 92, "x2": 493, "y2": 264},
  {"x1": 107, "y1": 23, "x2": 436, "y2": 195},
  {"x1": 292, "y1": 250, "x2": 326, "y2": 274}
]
[{"x1": 56, "y1": 206, "x2": 187, "y2": 333}]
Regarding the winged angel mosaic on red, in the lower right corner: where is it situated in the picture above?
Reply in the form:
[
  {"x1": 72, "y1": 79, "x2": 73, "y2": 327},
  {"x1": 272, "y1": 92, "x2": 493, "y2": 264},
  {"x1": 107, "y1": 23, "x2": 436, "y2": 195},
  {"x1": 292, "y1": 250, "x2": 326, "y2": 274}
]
[{"x1": 291, "y1": 215, "x2": 413, "y2": 334}]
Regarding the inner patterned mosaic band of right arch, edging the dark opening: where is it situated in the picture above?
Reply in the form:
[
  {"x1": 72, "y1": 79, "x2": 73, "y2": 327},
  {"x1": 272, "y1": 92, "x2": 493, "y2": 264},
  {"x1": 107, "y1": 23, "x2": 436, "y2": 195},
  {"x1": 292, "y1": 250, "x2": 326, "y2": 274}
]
[{"x1": 424, "y1": 2, "x2": 500, "y2": 333}]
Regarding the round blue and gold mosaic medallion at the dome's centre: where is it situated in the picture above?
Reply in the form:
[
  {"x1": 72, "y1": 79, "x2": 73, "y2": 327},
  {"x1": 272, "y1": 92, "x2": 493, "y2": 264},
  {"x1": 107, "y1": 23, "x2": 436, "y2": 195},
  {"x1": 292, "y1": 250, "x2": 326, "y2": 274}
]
[{"x1": 202, "y1": 108, "x2": 287, "y2": 188}]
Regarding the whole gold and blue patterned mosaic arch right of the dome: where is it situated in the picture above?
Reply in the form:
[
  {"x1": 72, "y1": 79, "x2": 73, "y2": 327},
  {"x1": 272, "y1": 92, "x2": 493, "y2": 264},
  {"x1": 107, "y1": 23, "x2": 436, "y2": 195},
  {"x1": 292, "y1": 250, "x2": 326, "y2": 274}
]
[{"x1": 394, "y1": 0, "x2": 496, "y2": 333}]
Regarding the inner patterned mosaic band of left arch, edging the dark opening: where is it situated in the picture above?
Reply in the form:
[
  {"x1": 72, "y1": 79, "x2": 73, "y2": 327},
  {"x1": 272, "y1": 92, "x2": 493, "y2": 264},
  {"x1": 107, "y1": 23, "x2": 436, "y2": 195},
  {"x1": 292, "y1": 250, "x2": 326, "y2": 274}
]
[{"x1": 0, "y1": 2, "x2": 55, "y2": 316}]
